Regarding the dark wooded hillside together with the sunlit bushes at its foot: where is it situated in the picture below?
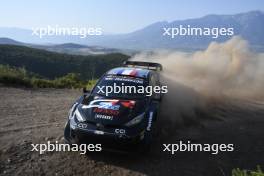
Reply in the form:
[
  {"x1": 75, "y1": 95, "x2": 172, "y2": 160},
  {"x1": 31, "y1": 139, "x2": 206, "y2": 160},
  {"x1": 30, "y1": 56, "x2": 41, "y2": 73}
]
[{"x1": 0, "y1": 45, "x2": 129, "y2": 90}]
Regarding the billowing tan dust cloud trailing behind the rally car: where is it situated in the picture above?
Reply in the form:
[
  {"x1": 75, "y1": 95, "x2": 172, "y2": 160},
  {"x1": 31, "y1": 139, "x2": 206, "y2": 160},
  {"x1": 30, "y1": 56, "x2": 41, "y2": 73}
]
[{"x1": 131, "y1": 36, "x2": 264, "y2": 124}]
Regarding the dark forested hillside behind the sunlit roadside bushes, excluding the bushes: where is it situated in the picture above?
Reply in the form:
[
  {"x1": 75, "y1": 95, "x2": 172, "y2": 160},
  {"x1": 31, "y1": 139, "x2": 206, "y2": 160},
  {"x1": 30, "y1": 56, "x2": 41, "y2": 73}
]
[{"x1": 0, "y1": 45, "x2": 128, "y2": 80}]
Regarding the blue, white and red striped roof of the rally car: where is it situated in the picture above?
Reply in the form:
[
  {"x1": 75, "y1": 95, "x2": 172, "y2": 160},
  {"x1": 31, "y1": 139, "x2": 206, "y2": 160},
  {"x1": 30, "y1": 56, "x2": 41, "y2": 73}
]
[{"x1": 106, "y1": 67, "x2": 151, "y2": 78}]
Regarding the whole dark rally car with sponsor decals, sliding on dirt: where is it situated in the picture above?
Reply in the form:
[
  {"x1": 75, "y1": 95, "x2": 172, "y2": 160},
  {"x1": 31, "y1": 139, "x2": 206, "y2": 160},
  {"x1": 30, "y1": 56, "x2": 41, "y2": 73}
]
[{"x1": 64, "y1": 61, "x2": 162, "y2": 151}]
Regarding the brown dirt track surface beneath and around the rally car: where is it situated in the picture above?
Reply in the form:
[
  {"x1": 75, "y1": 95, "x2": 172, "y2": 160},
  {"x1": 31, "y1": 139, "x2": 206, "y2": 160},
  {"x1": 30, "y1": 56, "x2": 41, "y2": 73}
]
[{"x1": 0, "y1": 87, "x2": 264, "y2": 176}]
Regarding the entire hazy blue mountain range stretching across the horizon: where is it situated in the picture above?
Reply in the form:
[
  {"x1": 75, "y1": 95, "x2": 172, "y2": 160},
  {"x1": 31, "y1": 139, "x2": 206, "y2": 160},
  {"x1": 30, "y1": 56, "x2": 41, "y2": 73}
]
[{"x1": 0, "y1": 11, "x2": 264, "y2": 51}]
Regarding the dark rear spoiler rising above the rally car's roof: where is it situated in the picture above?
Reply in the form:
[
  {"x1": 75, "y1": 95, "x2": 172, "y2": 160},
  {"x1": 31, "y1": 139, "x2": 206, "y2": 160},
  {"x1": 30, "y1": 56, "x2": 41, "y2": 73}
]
[{"x1": 123, "y1": 61, "x2": 162, "y2": 71}]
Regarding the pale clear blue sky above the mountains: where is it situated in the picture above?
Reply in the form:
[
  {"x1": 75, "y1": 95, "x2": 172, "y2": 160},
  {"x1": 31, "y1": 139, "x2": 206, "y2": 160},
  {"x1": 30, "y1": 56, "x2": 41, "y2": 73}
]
[{"x1": 0, "y1": 0, "x2": 264, "y2": 34}]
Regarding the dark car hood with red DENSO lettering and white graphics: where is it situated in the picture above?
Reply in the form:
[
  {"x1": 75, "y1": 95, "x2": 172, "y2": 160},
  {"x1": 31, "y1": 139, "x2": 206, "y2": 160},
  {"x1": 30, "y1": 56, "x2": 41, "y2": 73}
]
[{"x1": 77, "y1": 96, "x2": 147, "y2": 125}]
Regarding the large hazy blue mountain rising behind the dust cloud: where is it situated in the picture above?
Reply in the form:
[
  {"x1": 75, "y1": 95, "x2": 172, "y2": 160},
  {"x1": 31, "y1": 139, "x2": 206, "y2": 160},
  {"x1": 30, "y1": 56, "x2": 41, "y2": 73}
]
[{"x1": 85, "y1": 11, "x2": 264, "y2": 49}]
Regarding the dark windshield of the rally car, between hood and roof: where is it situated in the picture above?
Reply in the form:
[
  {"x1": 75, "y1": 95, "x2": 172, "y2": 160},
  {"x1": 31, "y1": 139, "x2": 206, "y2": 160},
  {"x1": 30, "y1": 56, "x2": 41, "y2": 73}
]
[{"x1": 92, "y1": 75, "x2": 146, "y2": 99}]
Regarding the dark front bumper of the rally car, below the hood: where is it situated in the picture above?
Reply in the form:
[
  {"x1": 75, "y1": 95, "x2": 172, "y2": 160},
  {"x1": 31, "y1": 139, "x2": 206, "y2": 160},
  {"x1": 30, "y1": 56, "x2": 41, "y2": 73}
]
[{"x1": 69, "y1": 118, "x2": 146, "y2": 148}]
